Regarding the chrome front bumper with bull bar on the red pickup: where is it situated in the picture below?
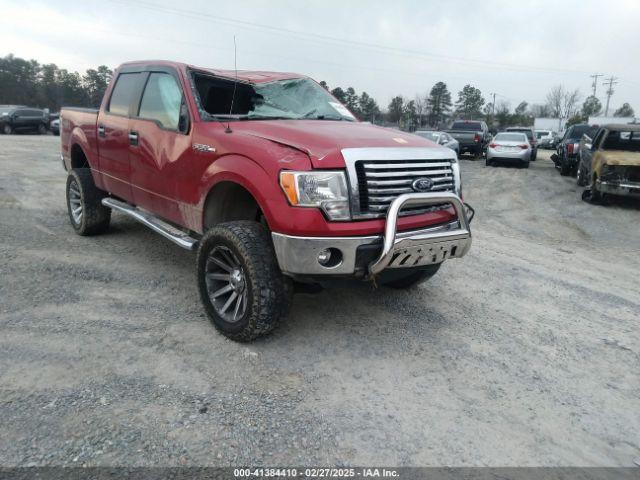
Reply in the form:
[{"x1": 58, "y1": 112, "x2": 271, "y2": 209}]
[{"x1": 272, "y1": 193, "x2": 471, "y2": 278}]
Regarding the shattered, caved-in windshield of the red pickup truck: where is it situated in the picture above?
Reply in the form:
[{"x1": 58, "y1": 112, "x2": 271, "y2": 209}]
[{"x1": 194, "y1": 74, "x2": 355, "y2": 121}]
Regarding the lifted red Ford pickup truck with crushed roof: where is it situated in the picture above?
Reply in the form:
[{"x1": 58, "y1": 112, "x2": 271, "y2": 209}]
[{"x1": 61, "y1": 61, "x2": 472, "y2": 341}]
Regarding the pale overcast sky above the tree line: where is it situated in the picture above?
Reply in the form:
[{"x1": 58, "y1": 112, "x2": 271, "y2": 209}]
[{"x1": 0, "y1": 0, "x2": 640, "y2": 112}]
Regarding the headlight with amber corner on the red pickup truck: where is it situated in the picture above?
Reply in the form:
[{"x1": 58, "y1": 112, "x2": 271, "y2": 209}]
[{"x1": 280, "y1": 170, "x2": 350, "y2": 220}]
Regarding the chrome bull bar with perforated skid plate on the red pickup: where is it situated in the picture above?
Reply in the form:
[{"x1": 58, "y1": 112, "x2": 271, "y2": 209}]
[{"x1": 369, "y1": 192, "x2": 471, "y2": 277}]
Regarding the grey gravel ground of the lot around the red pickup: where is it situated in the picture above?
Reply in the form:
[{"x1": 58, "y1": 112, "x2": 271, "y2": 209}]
[{"x1": 0, "y1": 135, "x2": 640, "y2": 466}]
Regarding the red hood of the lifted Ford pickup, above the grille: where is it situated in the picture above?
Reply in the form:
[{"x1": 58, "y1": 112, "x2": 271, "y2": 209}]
[{"x1": 232, "y1": 120, "x2": 442, "y2": 168}]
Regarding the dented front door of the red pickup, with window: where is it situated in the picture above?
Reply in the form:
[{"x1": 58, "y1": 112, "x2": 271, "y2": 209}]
[{"x1": 129, "y1": 67, "x2": 191, "y2": 224}]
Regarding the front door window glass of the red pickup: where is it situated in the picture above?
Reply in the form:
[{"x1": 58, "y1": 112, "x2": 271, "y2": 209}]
[{"x1": 138, "y1": 73, "x2": 182, "y2": 130}]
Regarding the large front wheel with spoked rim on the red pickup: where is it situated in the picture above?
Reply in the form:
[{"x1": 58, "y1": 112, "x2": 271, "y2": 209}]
[{"x1": 197, "y1": 221, "x2": 292, "y2": 342}]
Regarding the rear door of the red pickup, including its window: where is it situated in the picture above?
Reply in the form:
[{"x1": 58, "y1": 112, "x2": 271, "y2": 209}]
[{"x1": 98, "y1": 71, "x2": 144, "y2": 201}]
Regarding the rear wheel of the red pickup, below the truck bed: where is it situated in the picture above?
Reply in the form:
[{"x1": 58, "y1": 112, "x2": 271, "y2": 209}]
[{"x1": 67, "y1": 168, "x2": 111, "y2": 236}]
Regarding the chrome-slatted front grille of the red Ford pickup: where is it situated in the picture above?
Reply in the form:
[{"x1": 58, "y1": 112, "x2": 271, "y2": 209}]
[{"x1": 355, "y1": 159, "x2": 455, "y2": 216}]
